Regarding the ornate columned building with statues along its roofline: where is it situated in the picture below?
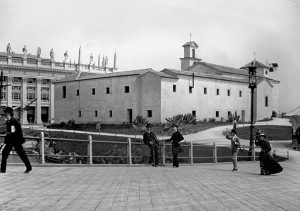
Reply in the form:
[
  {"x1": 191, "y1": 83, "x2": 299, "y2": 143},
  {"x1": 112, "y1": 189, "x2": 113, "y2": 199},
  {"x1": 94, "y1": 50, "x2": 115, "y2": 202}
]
[{"x1": 0, "y1": 44, "x2": 117, "y2": 125}]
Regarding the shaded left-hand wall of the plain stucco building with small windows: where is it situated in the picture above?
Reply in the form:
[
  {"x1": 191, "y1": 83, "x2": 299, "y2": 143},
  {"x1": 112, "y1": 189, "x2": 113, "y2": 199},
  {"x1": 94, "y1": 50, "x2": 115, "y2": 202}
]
[{"x1": 55, "y1": 75, "x2": 142, "y2": 124}]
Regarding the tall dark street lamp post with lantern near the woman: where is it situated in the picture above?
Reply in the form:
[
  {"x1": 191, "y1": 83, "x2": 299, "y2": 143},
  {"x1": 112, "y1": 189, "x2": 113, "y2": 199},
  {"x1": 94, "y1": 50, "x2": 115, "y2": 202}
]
[{"x1": 248, "y1": 60, "x2": 256, "y2": 160}]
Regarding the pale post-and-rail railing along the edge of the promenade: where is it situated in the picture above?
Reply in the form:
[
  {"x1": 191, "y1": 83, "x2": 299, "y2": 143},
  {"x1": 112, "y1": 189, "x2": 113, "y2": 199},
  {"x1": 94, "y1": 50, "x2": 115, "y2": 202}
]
[{"x1": 0, "y1": 132, "x2": 289, "y2": 165}]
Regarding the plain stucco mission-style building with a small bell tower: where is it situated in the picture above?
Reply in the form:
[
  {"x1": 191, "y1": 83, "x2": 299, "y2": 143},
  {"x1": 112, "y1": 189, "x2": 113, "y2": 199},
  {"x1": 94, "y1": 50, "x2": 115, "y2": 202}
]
[{"x1": 55, "y1": 41, "x2": 279, "y2": 124}]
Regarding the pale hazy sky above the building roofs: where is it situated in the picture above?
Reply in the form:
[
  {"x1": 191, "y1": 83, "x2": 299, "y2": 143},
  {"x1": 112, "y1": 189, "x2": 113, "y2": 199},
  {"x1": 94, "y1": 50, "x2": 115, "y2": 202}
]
[{"x1": 0, "y1": 0, "x2": 300, "y2": 112}]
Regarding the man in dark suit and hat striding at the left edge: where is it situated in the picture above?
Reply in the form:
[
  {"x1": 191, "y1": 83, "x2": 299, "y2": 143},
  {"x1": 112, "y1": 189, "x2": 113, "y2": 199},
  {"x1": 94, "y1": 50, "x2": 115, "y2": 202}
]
[{"x1": 0, "y1": 107, "x2": 32, "y2": 173}]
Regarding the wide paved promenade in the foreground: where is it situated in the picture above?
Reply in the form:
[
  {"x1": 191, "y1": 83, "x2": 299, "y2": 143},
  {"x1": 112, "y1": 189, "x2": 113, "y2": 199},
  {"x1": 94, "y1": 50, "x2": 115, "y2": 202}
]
[{"x1": 0, "y1": 161, "x2": 300, "y2": 211}]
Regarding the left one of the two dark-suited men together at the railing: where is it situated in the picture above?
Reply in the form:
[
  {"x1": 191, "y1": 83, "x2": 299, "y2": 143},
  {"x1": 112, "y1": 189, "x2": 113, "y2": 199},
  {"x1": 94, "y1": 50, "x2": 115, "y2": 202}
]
[{"x1": 143, "y1": 124, "x2": 159, "y2": 167}]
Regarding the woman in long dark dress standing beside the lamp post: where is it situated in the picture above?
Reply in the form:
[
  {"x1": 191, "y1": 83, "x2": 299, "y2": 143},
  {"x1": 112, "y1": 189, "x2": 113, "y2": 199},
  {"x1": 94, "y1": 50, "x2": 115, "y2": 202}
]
[{"x1": 255, "y1": 133, "x2": 282, "y2": 175}]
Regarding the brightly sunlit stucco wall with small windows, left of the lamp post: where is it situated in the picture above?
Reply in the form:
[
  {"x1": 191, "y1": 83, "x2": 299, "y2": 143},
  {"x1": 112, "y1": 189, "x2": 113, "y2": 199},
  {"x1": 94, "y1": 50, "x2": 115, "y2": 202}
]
[{"x1": 161, "y1": 76, "x2": 250, "y2": 122}]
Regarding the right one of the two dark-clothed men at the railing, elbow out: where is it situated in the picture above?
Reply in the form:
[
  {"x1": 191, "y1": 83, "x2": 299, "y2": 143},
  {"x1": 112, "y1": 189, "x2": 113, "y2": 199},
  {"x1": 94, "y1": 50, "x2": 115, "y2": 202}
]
[{"x1": 166, "y1": 126, "x2": 184, "y2": 168}]
